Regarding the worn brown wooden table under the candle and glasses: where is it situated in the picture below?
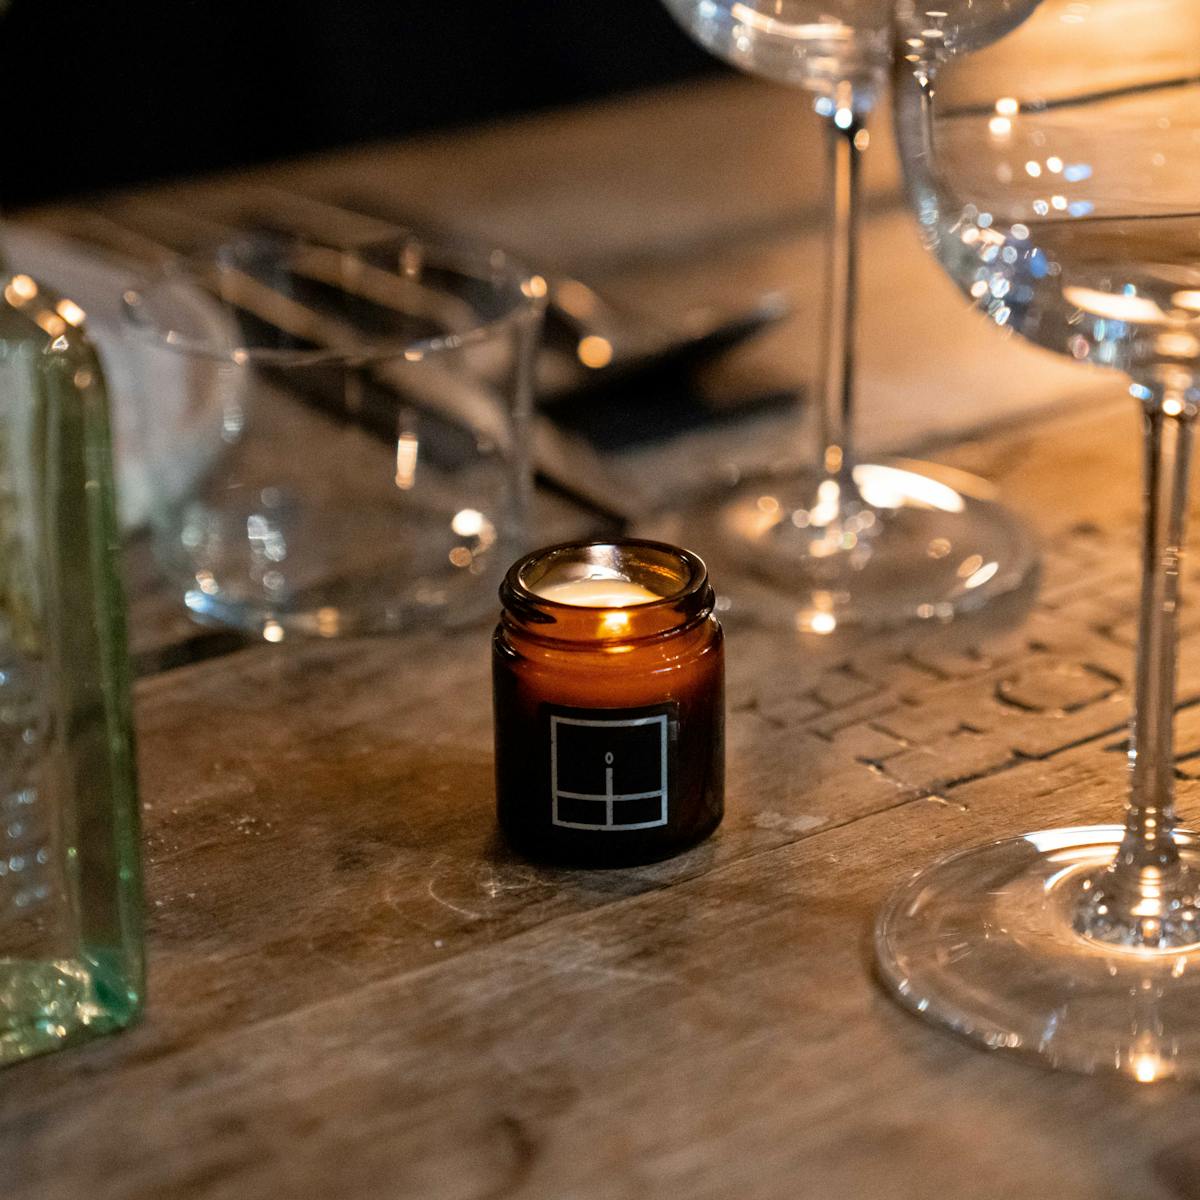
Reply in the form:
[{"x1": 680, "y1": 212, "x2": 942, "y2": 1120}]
[{"x1": 9, "y1": 82, "x2": 1200, "y2": 1200}]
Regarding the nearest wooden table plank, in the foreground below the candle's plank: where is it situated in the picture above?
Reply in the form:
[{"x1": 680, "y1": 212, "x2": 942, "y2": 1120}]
[{"x1": 9, "y1": 746, "x2": 1200, "y2": 1200}]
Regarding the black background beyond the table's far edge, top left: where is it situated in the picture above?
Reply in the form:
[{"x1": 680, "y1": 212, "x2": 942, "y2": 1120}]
[{"x1": 0, "y1": 0, "x2": 718, "y2": 208}]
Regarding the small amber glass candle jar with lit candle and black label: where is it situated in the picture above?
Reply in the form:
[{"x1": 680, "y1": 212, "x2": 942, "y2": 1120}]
[{"x1": 492, "y1": 541, "x2": 725, "y2": 866}]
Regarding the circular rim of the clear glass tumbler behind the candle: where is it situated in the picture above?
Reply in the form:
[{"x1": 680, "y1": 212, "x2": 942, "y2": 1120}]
[{"x1": 121, "y1": 228, "x2": 547, "y2": 367}]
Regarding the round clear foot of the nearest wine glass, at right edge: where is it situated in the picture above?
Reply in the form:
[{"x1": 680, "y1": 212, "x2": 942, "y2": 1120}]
[{"x1": 875, "y1": 826, "x2": 1200, "y2": 1082}]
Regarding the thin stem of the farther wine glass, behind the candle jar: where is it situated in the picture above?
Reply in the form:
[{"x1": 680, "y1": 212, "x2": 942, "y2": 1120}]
[{"x1": 820, "y1": 98, "x2": 868, "y2": 484}]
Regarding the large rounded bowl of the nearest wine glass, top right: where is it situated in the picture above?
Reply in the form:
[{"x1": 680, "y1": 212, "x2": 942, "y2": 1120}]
[{"x1": 896, "y1": 0, "x2": 1200, "y2": 373}]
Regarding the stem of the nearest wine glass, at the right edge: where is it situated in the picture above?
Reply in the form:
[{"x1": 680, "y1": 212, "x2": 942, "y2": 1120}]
[{"x1": 1122, "y1": 400, "x2": 1192, "y2": 869}]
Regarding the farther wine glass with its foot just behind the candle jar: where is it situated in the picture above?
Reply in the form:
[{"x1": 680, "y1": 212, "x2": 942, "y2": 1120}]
[{"x1": 644, "y1": 0, "x2": 1036, "y2": 634}]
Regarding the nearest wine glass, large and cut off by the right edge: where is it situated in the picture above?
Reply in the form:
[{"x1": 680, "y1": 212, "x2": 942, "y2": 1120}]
[{"x1": 876, "y1": 0, "x2": 1200, "y2": 1081}]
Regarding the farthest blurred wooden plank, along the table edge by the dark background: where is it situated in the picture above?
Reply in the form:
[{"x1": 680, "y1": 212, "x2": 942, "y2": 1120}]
[{"x1": 23, "y1": 78, "x2": 899, "y2": 271}]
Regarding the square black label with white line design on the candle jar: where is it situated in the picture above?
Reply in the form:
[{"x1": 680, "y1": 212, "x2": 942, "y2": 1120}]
[{"x1": 548, "y1": 704, "x2": 676, "y2": 833}]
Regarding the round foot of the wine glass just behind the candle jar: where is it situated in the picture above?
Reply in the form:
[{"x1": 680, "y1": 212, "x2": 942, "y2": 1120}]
[{"x1": 637, "y1": 460, "x2": 1037, "y2": 634}]
